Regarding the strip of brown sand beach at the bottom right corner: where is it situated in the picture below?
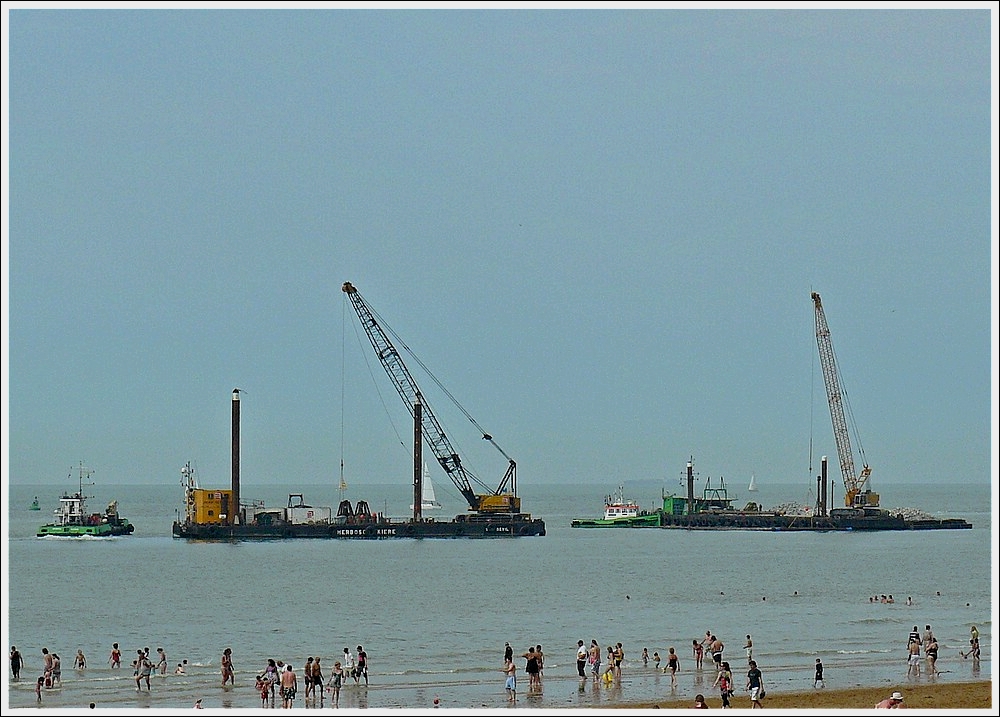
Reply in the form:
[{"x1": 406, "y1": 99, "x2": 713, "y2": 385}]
[{"x1": 618, "y1": 680, "x2": 996, "y2": 714}]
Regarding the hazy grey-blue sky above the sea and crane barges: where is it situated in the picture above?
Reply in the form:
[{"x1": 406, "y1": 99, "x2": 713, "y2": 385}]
[{"x1": 4, "y1": 9, "x2": 997, "y2": 506}]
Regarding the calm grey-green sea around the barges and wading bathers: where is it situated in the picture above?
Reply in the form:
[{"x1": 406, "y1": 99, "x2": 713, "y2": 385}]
[{"x1": 3, "y1": 478, "x2": 996, "y2": 714}]
